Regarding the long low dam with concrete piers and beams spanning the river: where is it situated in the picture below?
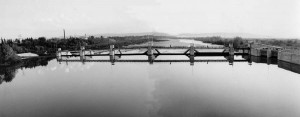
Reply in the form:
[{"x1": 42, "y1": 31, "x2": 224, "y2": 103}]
[{"x1": 57, "y1": 43, "x2": 255, "y2": 65}]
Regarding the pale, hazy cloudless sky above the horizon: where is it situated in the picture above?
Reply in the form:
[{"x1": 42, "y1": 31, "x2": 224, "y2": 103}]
[{"x1": 0, "y1": 0, "x2": 300, "y2": 38}]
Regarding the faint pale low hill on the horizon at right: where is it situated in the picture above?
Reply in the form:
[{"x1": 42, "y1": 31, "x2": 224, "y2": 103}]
[{"x1": 177, "y1": 33, "x2": 270, "y2": 38}]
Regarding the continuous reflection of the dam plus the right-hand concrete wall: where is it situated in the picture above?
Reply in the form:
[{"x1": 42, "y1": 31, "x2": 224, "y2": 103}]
[{"x1": 57, "y1": 55, "x2": 300, "y2": 74}]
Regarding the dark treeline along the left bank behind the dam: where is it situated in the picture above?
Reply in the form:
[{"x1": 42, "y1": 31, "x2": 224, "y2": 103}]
[{"x1": 1, "y1": 35, "x2": 160, "y2": 55}]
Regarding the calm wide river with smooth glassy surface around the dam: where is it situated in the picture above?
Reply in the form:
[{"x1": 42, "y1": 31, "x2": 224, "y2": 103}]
[{"x1": 0, "y1": 40, "x2": 300, "y2": 117}]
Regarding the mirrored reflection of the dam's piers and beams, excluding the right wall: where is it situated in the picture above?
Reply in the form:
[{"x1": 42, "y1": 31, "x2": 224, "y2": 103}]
[{"x1": 57, "y1": 55, "x2": 251, "y2": 66}]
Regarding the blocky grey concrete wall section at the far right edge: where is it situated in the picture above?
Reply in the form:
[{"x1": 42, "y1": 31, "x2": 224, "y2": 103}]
[{"x1": 278, "y1": 50, "x2": 300, "y2": 65}]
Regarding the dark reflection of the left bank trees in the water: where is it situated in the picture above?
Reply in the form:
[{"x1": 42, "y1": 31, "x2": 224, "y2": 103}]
[{"x1": 0, "y1": 57, "x2": 54, "y2": 84}]
